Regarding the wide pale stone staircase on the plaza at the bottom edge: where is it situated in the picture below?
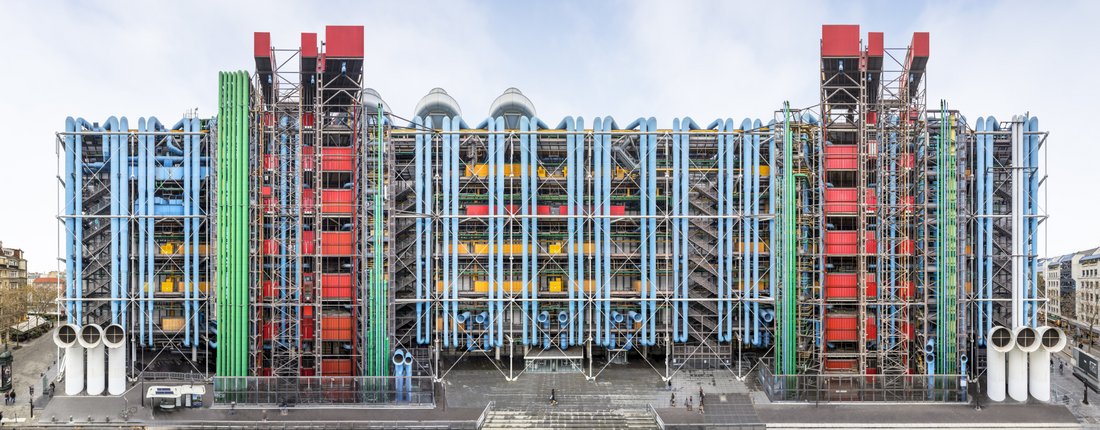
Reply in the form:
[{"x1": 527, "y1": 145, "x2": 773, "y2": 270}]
[{"x1": 481, "y1": 409, "x2": 660, "y2": 430}]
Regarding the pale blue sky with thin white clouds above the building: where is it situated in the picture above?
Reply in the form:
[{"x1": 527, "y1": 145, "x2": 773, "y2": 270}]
[{"x1": 0, "y1": 0, "x2": 1100, "y2": 271}]
